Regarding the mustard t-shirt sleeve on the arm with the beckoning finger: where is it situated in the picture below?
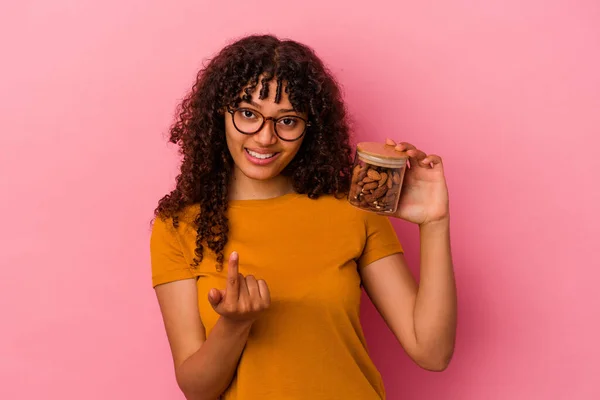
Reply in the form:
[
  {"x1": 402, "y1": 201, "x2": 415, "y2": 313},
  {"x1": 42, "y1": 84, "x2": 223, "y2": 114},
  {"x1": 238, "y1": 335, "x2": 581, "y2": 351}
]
[{"x1": 150, "y1": 217, "x2": 194, "y2": 287}]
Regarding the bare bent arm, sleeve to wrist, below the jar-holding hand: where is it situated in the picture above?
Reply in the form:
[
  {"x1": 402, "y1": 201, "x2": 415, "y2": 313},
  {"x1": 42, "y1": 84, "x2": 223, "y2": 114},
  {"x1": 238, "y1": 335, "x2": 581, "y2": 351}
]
[{"x1": 361, "y1": 219, "x2": 457, "y2": 371}]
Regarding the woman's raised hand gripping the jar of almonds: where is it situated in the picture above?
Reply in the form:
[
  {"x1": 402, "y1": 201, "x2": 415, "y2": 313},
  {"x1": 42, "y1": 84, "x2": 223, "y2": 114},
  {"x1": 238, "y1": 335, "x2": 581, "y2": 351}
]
[{"x1": 386, "y1": 139, "x2": 449, "y2": 225}]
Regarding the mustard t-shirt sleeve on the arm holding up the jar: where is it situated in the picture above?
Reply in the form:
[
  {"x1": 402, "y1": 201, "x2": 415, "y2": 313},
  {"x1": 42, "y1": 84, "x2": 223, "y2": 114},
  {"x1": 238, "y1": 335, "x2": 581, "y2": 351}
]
[{"x1": 358, "y1": 211, "x2": 404, "y2": 268}]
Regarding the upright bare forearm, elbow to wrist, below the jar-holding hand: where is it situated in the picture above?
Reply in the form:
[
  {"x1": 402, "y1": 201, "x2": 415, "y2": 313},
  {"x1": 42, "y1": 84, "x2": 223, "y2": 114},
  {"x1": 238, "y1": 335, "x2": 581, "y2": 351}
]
[{"x1": 414, "y1": 219, "x2": 457, "y2": 369}]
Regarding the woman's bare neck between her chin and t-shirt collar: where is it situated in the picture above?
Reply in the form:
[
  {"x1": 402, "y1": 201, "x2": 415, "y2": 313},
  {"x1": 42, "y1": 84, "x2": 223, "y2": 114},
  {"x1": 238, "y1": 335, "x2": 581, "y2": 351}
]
[{"x1": 229, "y1": 167, "x2": 294, "y2": 200}]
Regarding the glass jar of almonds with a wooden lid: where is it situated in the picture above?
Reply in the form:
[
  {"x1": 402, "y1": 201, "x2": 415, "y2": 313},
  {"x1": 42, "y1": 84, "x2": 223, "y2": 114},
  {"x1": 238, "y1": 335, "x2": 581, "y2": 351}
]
[{"x1": 348, "y1": 142, "x2": 408, "y2": 214}]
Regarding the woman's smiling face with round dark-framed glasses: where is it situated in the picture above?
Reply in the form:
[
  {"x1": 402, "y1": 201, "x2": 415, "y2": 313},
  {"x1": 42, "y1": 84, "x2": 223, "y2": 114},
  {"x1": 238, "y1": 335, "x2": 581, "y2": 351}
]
[{"x1": 225, "y1": 80, "x2": 306, "y2": 180}]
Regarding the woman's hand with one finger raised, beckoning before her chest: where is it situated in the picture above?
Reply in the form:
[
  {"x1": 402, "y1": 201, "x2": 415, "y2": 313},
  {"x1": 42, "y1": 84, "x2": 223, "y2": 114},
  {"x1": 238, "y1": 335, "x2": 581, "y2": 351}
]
[{"x1": 208, "y1": 251, "x2": 271, "y2": 323}]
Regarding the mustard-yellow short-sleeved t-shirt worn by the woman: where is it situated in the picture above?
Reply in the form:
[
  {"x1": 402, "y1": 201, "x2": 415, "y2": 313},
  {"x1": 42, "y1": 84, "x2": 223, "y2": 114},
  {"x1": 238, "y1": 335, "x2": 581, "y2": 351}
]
[{"x1": 151, "y1": 194, "x2": 402, "y2": 400}]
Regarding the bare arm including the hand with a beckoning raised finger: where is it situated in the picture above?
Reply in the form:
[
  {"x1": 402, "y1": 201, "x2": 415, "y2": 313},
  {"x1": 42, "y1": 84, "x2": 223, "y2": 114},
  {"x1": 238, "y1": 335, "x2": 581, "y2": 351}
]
[{"x1": 155, "y1": 254, "x2": 270, "y2": 400}]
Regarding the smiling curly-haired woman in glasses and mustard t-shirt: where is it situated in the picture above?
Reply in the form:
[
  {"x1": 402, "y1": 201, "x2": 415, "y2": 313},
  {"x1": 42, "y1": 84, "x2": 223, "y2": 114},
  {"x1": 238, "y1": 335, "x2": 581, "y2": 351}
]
[{"x1": 151, "y1": 36, "x2": 456, "y2": 400}]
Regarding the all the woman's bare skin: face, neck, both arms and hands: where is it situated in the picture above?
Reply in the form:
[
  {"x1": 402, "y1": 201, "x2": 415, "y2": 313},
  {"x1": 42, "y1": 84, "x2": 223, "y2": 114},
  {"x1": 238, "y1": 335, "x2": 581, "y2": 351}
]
[{"x1": 155, "y1": 82, "x2": 456, "y2": 400}]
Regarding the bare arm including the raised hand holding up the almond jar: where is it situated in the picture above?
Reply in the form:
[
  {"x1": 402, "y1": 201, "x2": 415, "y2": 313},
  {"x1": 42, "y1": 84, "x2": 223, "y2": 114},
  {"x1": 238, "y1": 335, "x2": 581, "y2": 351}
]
[{"x1": 362, "y1": 139, "x2": 457, "y2": 371}]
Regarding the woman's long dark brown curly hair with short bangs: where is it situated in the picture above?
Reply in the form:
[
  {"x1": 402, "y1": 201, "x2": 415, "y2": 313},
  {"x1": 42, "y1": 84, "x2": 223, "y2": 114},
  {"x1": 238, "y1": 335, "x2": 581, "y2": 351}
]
[{"x1": 154, "y1": 35, "x2": 352, "y2": 271}]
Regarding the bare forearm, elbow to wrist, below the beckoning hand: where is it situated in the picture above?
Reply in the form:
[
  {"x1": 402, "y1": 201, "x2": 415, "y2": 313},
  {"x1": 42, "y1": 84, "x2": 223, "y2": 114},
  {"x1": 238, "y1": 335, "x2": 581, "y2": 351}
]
[{"x1": 176, "y1": 317, "x2": 251, "y2": 400}]
